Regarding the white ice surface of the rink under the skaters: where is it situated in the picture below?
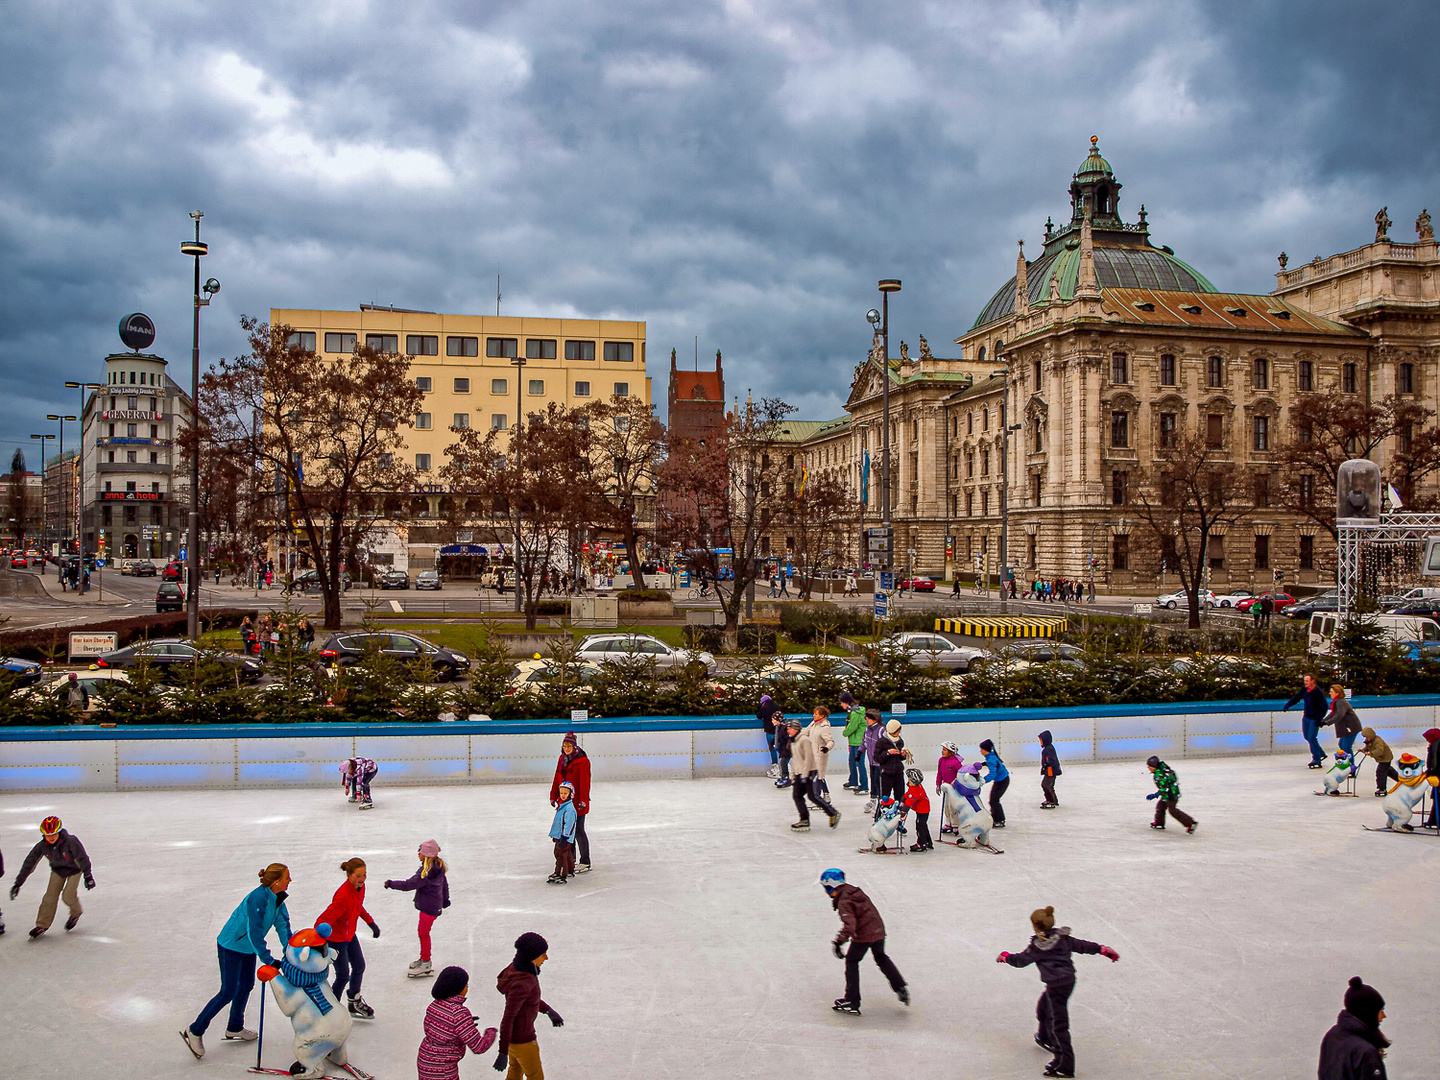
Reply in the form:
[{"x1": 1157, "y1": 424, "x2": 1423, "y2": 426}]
[{"x1": 0, "y1": 746, "x2": 1440, "y2": 1080}]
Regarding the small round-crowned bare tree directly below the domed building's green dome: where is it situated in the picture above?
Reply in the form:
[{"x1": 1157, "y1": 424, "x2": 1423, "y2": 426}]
[{"x1": 1130, "y1": 435, "x2": 1253, "y2": 629}]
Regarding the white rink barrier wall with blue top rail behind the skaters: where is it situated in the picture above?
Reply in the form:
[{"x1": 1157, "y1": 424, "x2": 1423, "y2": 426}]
[{"x1": 0, "y1": 694, "x2": 1440, "y2": 792}]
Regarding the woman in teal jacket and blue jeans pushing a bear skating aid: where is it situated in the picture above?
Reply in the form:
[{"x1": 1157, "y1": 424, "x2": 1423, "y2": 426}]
[{"x1": 180, "y1": 863, "x2": 292, "y2": 1058}]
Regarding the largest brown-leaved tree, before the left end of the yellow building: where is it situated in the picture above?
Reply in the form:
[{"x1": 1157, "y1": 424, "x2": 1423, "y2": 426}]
[{"x1": 200, "y1": 318, "x2": 423, "y2": 629}]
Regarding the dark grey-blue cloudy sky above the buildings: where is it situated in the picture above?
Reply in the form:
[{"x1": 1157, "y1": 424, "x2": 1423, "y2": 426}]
[{"x1": 0, "y1": 0, "x2": 1440, "y2": 462}]
